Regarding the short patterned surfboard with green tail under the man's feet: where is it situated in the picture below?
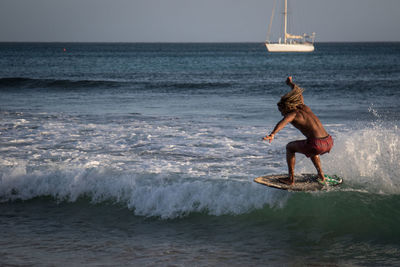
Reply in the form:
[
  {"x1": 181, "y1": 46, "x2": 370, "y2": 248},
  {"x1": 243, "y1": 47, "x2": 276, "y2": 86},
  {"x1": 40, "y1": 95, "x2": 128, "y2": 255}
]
[{"x1": 254, "y1": 173, "x2": 343, "y2": 192}]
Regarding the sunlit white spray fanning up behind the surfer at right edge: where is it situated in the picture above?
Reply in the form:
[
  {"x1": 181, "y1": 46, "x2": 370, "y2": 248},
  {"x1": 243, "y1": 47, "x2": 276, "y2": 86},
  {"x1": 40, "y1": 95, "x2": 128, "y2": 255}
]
[{"x1": 336, "y1": 125, "x2": 400, "y2": 193}]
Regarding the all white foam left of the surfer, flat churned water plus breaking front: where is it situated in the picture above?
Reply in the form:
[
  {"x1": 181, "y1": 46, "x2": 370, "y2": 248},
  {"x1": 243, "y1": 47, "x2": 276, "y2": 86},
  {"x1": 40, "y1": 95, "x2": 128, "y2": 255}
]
[{"x1": 0, "y1": 116, "x2": 287, "y2": 218}]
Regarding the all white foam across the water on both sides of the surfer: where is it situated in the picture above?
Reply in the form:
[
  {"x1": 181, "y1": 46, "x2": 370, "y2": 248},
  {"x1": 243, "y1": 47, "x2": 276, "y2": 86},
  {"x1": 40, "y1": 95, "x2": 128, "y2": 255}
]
[{"x1": 0, "y1": 110, "x2": 400, "y2": 218}]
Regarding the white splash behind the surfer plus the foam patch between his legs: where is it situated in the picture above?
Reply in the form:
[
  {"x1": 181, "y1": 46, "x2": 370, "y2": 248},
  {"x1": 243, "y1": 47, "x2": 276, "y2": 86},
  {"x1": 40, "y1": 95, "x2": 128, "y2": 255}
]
[{"x1": 301, "y1": 123, "x2": 400, "y2": 194}]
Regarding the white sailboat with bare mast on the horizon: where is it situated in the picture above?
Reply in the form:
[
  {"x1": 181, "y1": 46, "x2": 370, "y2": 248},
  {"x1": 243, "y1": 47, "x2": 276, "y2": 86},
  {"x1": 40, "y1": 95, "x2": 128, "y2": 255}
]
[{"x1": 265, "y1": 0, "x2": 315, "y2": 52}]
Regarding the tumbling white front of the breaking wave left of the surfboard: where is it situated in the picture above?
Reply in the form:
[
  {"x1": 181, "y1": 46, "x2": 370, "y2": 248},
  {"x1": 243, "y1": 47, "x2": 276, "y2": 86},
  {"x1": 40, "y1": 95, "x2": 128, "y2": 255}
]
[{"x1": 0, "y1": 166, "x2": 288, "y2": 218}]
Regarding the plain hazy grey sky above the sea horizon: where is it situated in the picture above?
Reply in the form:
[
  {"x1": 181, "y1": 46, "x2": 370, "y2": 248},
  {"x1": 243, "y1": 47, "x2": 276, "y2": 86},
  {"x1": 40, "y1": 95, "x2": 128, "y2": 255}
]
[{"x1": 0, "y1": 0, "x2": 400, "y2": 42}]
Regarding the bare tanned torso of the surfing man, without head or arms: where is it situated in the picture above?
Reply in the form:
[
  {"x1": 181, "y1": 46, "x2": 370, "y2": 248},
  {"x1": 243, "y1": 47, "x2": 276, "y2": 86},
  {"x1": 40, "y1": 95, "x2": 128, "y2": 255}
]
[{"x1": 291, "y1": 105, "x2": 328, "y2": 138}]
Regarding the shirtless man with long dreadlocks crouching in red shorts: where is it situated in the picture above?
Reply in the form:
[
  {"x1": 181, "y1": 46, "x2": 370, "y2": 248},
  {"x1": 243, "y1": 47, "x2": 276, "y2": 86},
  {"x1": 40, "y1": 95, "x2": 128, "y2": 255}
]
[{"x1": 263, "y1": 77, "x2": 333, "y2": 185}]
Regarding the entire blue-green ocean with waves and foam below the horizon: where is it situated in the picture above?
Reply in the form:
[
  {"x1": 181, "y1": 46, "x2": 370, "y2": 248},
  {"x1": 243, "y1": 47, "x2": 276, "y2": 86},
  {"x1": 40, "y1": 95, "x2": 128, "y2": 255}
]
[{"x1": 0, "y1": 43, "x2": 400, "y2": 266}]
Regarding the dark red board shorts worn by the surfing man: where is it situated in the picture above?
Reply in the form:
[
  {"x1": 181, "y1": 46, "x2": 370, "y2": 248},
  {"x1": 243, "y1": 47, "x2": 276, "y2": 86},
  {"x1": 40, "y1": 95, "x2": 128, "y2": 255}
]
[{"x1": 299, "y1": 135, "x2": 333, "y2": 158}]
